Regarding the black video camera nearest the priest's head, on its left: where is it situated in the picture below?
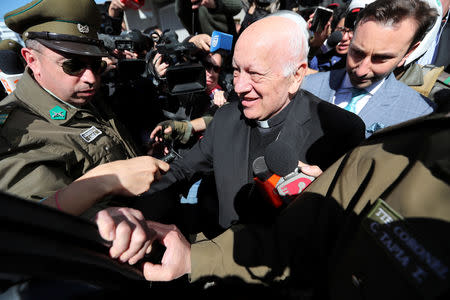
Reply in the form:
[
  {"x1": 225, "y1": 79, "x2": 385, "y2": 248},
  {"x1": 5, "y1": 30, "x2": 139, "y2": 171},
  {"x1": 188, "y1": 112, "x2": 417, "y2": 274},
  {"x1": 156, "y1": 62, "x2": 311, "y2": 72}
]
[{"x1": 147, "y1": 30, "x2": 206, "y2": 95}]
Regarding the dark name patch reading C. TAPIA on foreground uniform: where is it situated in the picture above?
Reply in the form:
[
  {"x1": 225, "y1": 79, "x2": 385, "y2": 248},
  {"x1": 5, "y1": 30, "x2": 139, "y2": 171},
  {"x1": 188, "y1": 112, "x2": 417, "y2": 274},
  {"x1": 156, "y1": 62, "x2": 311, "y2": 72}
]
[{"x1": 363, "y1": 199, "x2": 449, "y2": 295}]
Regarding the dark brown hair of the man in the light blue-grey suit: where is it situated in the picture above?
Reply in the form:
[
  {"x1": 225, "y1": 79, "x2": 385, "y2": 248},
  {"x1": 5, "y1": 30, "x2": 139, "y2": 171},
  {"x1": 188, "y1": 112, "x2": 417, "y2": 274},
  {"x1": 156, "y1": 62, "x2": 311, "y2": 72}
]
[{"x1": 356, "y1": 0, "x2": 438, "y2": 47}]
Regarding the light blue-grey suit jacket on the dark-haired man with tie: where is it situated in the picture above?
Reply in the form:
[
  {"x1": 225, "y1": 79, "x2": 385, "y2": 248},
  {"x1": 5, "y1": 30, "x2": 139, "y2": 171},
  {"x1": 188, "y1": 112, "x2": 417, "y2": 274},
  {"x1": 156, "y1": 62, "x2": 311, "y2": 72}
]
[{"x1": 302, "y1": 69, "x2": 434, "y2": 137}]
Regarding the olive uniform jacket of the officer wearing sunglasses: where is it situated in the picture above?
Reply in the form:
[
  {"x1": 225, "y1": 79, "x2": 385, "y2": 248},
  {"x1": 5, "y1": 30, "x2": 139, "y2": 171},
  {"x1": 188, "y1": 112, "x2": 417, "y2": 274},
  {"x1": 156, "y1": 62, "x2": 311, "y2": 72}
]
[{"x1": 0, "y1": 70, "x2": 137, "y2": 206}]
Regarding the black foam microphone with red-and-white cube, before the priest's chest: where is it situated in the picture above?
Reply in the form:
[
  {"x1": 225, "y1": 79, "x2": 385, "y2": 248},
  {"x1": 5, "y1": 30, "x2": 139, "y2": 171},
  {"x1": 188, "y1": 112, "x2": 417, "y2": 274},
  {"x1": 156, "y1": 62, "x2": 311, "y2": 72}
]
[{"x1": 264, "y1": 140, "x2": 315, "y2": 198}]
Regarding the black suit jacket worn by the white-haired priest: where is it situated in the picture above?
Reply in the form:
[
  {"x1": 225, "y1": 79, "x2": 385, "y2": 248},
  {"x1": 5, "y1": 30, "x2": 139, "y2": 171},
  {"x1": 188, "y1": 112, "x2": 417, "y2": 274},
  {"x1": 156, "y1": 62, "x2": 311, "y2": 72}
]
[{"x1": 140, "y1": 89, "x2": 365, "y2": 228}]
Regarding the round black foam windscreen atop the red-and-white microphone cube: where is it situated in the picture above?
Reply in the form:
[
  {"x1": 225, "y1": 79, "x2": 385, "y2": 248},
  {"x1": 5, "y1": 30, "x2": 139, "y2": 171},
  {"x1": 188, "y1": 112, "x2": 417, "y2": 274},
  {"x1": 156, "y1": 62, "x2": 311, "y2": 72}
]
[{"x1": 264, "y1": 140, "x2": 298, "y2": 177}]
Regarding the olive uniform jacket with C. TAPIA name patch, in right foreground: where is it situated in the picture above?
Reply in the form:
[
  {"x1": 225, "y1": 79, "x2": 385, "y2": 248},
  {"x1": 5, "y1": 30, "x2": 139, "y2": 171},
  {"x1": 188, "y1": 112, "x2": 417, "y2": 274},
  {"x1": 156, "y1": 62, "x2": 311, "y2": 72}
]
[{"x1": 190, "y1": 109, "x2": 450, "y2": 299}]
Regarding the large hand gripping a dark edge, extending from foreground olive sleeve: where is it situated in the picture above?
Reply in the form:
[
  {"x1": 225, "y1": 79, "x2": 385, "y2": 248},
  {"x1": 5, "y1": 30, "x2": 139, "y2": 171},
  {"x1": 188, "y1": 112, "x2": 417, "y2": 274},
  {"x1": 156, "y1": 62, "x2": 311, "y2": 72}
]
[{"x1": 95, "y1": 207, "x2": 191, "y2": 281}]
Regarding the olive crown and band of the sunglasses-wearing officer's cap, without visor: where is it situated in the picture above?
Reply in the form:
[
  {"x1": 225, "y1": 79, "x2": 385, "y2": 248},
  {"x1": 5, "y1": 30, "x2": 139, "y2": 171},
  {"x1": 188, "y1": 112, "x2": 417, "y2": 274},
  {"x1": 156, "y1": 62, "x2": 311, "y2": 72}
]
[{"x1": 4, "y1": 0, "x2": 101, "y2": 39}]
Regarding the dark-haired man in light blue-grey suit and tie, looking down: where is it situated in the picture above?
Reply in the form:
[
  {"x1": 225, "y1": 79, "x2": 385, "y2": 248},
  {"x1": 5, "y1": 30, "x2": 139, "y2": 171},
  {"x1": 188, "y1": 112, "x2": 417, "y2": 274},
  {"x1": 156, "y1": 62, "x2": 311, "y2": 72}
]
[{"x1": 302, "y1": 0, "x2": 437, "y2": 137}]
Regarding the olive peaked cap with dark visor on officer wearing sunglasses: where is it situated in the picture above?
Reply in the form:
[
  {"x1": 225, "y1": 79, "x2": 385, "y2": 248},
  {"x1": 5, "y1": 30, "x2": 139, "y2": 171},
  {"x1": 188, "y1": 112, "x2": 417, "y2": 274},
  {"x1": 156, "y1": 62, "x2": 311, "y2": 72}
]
[{"x1": 4, "y1": 0, "x2": 107, "y2": 56}]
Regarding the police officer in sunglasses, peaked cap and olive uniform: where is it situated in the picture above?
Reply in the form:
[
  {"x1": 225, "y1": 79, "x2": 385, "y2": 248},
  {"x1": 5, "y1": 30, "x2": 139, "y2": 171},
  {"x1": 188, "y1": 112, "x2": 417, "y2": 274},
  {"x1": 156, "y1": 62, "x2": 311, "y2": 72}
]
[{"x1": 0, "y1": 0, "x2": 169, "y2": 217}]
